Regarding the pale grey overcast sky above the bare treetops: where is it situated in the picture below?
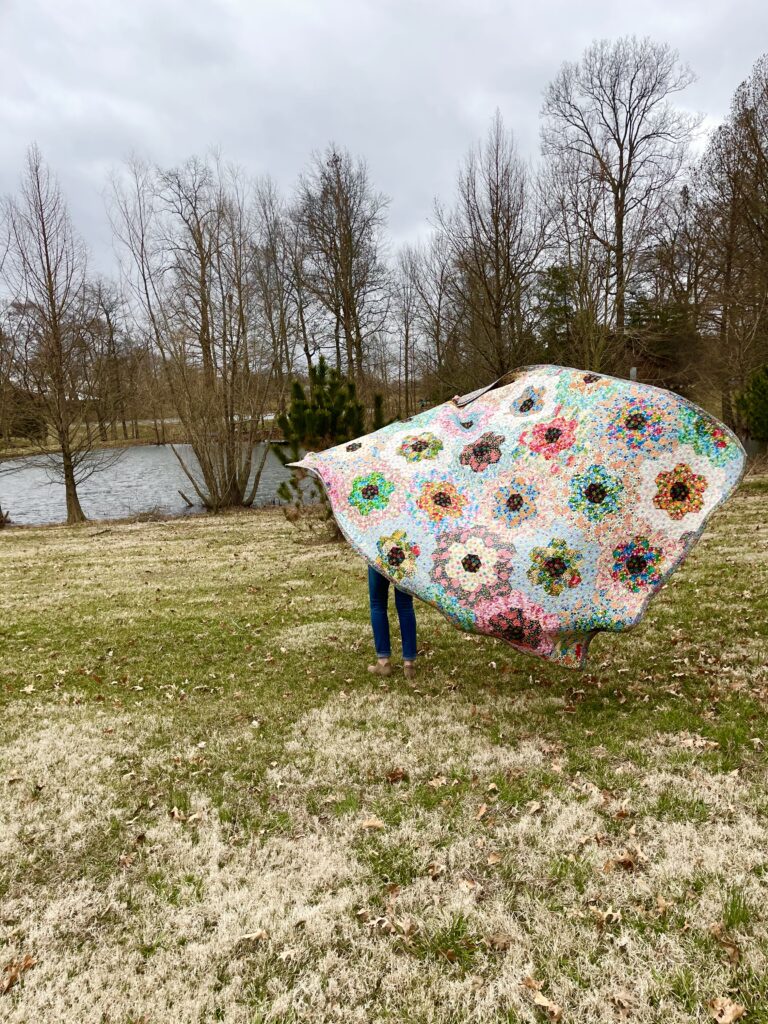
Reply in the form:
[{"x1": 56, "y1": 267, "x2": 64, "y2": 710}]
[{"x1": 0, "y1": 0, "x2": 768, "y2": 272}]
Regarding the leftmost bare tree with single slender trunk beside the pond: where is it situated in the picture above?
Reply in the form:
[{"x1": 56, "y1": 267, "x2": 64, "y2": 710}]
[{"x1": 3, "y1": 145, "x2": 117, "y2": 523}]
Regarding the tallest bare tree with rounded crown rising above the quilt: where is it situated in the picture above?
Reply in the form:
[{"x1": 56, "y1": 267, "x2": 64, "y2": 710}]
[{"x1": 542, "y1": 37, "x2": 698, "y2": 335}]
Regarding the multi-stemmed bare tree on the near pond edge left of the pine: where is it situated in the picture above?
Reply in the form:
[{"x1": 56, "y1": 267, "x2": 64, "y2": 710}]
[{"x1": 114, "y1": 152, "x2": 275, "y2": 511}]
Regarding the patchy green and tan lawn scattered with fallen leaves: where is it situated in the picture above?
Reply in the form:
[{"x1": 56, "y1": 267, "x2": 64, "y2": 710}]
[{"x1": 0, "y1": 480, "x2": 768, "y2": 1024}]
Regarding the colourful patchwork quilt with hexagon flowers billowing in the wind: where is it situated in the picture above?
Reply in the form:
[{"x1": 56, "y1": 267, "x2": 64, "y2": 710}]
[{"x1": 293, "y1": 366, "x2": 745, "y2": 668}]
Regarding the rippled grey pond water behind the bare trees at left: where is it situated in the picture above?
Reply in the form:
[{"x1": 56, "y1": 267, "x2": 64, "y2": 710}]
[{"x1": 0, "y1": 444, "x2": 303, "y2": 526}]
